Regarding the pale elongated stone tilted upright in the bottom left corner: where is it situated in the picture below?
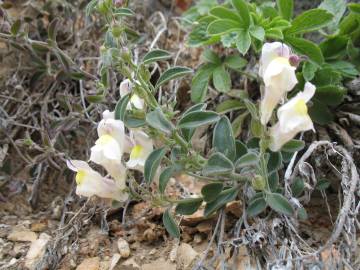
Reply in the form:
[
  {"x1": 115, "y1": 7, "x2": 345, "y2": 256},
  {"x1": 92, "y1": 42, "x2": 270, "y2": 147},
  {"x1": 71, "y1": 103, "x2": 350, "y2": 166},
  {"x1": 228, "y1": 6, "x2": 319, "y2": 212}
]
[{"x1": 25, "y1": 233, "x2": 51, "y2": 270}]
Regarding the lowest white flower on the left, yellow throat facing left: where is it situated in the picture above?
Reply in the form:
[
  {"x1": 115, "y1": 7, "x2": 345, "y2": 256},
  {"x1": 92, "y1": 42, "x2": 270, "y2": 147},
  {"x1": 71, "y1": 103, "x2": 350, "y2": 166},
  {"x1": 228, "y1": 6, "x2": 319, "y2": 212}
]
[{"x1": 67, "y1": 160, "x2": 128, "y2": 201}]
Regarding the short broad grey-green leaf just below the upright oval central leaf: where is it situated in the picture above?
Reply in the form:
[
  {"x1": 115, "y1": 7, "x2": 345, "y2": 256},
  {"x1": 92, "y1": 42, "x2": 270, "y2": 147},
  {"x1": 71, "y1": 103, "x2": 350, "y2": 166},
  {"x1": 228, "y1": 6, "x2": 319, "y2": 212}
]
[{"x1": 202, "y1": 153, "x2": 234, "y2": 175}]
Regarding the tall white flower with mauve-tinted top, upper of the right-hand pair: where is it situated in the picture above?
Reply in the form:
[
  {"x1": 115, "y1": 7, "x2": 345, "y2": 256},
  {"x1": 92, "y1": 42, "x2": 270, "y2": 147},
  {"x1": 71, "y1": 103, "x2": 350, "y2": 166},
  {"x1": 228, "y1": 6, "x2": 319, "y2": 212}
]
[{"x1": 259, "y1": 42, "x2": 298, "y2": 125}]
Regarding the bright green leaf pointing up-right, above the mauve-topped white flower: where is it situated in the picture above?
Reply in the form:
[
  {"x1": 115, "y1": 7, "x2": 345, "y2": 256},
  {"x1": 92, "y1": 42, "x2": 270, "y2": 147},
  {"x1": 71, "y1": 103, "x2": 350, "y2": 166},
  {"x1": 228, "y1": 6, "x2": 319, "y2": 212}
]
[{"x1": 286, "y1": 8, "x2": 333, "y2": 35}]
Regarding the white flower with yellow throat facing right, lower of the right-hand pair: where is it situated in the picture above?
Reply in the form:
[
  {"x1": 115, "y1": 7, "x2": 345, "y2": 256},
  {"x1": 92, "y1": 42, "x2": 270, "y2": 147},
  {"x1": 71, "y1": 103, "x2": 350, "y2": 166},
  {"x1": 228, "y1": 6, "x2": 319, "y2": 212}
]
[{"x1": 269, "y1": 82, "x2": 315, "y2": 151}]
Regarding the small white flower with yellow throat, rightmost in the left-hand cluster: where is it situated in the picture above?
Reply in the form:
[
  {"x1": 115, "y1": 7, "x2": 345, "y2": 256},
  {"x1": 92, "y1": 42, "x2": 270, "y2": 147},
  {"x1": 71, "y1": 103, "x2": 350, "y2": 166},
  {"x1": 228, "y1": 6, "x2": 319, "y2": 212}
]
[{"x1": 126, "y1": 130, "x2": 153, "y2": 172}]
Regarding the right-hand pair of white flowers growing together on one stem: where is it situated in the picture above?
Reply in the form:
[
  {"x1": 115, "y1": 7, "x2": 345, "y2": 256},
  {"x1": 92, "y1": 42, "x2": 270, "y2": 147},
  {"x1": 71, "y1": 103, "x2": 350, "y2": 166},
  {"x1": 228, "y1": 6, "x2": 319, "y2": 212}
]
[{"x1": 259, "y1": 42, "x2": 315, "y2": 151}]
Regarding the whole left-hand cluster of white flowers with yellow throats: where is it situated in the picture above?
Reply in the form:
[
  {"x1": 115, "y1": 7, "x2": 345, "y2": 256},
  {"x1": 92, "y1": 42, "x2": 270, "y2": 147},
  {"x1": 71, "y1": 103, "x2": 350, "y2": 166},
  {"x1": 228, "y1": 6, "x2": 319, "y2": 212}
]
[{"x1": 67, "y1": 80, "x2": 153, "y2": 201}]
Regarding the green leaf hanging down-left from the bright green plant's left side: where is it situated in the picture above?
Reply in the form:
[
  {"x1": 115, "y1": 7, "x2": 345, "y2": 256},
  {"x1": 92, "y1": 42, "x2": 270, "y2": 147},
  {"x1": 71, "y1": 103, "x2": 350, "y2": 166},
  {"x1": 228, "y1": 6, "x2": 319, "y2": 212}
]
[{"x1": 191, "y1": 64, "x2": 215, "y2": 102}]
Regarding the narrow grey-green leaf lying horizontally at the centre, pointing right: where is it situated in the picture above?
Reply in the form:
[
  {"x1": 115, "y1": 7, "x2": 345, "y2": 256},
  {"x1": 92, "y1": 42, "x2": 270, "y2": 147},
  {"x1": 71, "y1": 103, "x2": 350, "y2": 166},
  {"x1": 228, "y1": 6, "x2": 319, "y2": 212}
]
[{"x1": 178, "y1": 111, "x2": 220, "y2": 128}]
